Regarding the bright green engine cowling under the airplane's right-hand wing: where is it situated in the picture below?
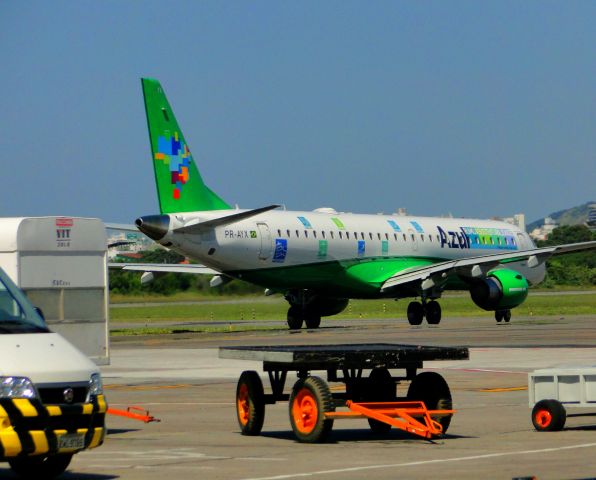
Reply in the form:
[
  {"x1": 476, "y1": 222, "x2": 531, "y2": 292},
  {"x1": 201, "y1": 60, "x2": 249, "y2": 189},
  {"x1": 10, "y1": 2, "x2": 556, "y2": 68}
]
[{"x1": 470, "y1": 269, "x2": 528, "y2": 310}]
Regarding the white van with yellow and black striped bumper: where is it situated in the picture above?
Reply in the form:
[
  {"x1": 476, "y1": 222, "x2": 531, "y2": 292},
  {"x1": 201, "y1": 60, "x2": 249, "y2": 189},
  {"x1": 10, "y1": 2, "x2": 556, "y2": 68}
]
[{"x1": 0, "y1": 269, "x2": 107, "y2": 478}]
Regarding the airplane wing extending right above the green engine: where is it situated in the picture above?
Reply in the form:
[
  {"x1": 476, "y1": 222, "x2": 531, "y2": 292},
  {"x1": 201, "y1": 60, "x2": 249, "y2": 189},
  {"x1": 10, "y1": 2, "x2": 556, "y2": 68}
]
[{"x1": 381, "y1": 241, "x2": 596, "y2": 292}]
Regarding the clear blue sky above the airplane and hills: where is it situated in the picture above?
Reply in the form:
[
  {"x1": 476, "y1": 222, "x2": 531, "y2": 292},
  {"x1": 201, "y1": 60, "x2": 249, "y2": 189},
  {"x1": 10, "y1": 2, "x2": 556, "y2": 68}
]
[{"x1": 0, "y1": 1, "x2": 596, "y2": 223}]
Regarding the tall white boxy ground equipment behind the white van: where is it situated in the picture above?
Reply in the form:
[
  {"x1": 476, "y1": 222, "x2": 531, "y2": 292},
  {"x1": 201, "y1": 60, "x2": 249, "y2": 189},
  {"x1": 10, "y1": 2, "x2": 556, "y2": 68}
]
[{"x1": 0, "y1": 217, "x2": 109, "y2": 364}]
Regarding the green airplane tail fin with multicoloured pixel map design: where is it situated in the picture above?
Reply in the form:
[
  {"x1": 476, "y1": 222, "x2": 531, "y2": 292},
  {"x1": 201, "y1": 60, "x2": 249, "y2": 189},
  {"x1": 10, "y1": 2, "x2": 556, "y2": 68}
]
[{"x1": 141, "y1": 78, "x2": 232, "y2": 213}]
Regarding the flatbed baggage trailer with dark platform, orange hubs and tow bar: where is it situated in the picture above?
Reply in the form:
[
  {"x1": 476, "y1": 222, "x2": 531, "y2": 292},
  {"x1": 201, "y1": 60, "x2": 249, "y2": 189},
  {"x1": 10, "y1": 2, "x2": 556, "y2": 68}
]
[{"x1": 219, "y1": 343, "x2": 469, "y2": 443}]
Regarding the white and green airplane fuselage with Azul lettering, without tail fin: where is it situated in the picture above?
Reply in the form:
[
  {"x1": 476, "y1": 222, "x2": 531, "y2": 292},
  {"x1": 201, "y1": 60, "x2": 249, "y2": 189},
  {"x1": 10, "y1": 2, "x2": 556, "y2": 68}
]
[{"x1": 144, "y1": 209, "x2": 545, "y2": 298}]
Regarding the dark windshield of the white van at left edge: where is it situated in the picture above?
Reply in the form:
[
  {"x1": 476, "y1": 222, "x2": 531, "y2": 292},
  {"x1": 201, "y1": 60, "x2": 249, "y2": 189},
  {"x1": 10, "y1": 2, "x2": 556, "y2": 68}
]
[{"x1": 0, "y1": 269, "x2": 49, "y2": 334}]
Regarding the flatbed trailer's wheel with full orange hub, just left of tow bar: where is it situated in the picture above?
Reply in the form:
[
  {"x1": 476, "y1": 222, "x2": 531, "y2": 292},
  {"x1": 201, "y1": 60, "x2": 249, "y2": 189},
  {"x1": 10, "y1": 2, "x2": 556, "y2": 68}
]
[{"x1": 290, "y1": 377, "x2": 335, "y2": 443}]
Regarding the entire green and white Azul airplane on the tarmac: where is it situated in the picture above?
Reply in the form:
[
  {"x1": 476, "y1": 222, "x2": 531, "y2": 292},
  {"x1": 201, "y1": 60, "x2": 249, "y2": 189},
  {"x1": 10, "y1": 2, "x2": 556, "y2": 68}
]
[{"x1": 125, "y1": 78, "x2": 596, "y2": 329}]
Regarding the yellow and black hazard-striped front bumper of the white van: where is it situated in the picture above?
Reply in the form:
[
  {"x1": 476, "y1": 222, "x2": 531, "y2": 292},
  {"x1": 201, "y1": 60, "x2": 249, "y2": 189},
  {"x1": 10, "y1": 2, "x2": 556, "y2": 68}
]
[{"x1": 0, "y1": 395, "x2": 107, "y2": 459}]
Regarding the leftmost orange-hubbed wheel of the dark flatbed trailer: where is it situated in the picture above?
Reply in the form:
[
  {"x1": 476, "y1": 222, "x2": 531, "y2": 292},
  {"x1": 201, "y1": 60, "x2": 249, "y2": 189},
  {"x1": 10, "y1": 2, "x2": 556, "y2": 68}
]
[{"x1": 236, "y1": 370, "x2": 265, "y2": 435}]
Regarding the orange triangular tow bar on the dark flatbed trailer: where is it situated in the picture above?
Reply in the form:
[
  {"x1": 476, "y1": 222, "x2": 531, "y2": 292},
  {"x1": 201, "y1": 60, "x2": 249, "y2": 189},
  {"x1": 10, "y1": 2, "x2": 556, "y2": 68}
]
[{"x1": 325, "y1": 400, "x2": 455, "y2": 439}]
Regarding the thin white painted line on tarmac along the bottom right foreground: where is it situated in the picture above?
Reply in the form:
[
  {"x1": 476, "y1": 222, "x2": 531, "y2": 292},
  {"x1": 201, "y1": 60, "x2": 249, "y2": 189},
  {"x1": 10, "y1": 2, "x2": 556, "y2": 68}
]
[{"x1": 244, "y1": 443, "x2": 596, "y2": 480}]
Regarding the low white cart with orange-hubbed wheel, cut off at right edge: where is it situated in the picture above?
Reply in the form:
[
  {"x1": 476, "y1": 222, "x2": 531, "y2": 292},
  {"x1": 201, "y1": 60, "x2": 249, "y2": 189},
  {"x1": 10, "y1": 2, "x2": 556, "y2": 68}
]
[{"x1": 528, "y1": 365, "x2": 596, "y2": 431}]
